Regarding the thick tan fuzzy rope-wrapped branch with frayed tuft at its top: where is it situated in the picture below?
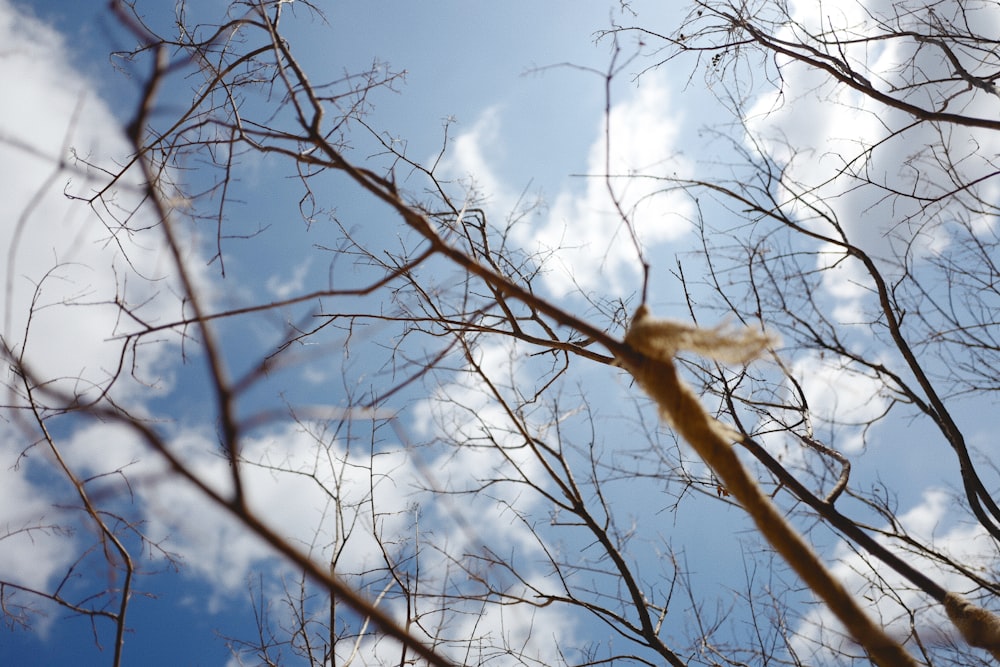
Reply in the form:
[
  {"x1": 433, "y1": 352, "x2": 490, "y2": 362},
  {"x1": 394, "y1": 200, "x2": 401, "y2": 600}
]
[{"x1": 620, "y1": 305, "x2": 917, "y2": 667}]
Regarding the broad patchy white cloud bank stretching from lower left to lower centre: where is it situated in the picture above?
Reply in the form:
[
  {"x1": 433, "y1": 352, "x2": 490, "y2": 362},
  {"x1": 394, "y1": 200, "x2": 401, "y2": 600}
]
[{"x1": 41, "y1": 344, "x2": 573, "y2": 662}]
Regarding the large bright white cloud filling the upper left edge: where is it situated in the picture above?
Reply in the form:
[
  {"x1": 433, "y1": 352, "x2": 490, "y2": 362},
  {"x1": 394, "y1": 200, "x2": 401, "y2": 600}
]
[{"x1": 0, "y1": 2, "x2": 180, "y2": 408}]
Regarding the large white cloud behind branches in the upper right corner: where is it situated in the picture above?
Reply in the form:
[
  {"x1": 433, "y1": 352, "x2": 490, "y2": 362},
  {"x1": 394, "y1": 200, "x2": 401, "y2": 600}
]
[{"x1": 747, "y1": 1, "x2": 1000, "y2": 321}]
